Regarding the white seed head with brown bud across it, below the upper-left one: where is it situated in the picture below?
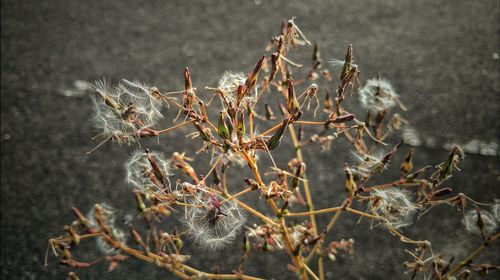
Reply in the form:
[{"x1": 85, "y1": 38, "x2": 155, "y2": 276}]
[{"x1": 125, "y1": 150, "x2": 173, "y2": 192}]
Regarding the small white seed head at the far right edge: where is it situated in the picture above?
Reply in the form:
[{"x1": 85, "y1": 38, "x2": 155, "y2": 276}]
[{"x1": 462, "y1": 209, "x2": 498, "y2": 236}]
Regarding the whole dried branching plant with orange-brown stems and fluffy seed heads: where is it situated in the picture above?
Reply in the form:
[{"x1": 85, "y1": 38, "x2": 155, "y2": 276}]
[{"x1": 45, "y1": 19, "x2": 500, "y2": 279}]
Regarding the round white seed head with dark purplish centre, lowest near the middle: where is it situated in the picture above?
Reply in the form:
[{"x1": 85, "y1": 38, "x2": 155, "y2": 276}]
[{"x1": 185, "y1": 189, "x2": 246, "y2": 251}]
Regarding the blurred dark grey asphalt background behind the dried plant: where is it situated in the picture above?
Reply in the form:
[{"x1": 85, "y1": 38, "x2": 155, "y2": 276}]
[{"x1": 0, "y1": 0, "x2": 500, "y2": 279}]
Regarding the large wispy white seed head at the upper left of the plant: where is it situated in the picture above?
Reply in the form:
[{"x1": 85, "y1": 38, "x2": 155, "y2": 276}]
[{"x1": 92, "y1": 80, "x2": 163, "y2": 143}]
